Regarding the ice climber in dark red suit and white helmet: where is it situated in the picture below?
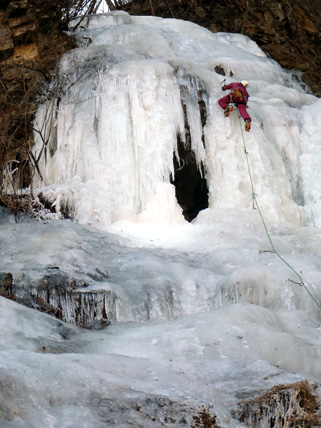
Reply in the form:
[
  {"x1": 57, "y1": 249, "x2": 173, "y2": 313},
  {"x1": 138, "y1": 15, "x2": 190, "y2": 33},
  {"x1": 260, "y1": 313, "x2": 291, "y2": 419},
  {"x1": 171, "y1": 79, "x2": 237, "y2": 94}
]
[{"x1": 218, "y1": 80, "x2": 251, "y2": 131}]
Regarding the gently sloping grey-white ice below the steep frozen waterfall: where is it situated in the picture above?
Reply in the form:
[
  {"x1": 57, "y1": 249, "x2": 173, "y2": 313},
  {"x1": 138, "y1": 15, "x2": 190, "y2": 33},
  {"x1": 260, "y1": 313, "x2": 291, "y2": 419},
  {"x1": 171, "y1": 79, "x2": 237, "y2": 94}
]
[{"x1": 0, "y1": 206, "x2": 321, "y2": 428}]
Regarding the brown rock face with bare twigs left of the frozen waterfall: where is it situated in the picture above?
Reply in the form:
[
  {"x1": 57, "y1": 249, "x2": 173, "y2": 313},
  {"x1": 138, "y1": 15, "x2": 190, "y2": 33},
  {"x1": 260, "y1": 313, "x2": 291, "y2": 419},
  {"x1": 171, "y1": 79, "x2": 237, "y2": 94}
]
[{"x1": 0, "y1": 0, "x2": 73, "y2": 191}]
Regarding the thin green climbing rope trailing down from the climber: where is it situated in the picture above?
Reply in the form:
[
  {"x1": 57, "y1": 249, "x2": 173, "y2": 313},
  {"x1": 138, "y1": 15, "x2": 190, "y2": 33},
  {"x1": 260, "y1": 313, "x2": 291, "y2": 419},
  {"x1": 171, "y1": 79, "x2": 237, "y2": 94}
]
[{"x1": 238, "y1": 115, "x2": 321, "y2": 309}]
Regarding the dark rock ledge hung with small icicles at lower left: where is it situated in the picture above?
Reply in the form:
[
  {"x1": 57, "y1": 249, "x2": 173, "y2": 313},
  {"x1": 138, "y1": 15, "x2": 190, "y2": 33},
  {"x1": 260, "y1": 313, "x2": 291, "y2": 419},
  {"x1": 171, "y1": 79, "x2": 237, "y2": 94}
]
[{"x1": 0, "y1": 266, "x2": 112, "y2": 329}]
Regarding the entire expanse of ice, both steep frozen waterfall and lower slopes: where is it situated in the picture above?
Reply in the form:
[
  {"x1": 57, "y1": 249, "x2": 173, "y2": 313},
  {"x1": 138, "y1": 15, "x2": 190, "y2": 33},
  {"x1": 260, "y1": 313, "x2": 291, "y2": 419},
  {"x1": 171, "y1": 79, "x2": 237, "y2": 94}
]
[{"x1": 0, "y1": 12, "x2": 321, "y2": 428}]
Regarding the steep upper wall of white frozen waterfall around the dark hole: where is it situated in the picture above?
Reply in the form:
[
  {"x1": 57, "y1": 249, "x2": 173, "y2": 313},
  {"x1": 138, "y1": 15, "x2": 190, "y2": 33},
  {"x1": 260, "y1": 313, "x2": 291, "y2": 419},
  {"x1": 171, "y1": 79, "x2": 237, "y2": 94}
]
[{"x1": 34, "y1": 12, "x2": 321, "y2": 228}]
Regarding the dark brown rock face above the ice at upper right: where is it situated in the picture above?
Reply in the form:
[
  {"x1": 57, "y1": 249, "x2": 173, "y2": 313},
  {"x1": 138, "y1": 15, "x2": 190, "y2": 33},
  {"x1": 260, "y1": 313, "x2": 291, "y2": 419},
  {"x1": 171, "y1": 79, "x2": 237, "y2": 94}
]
[{"x1": 123, "y1": 0, "x2": 321, "y2": 96}]
